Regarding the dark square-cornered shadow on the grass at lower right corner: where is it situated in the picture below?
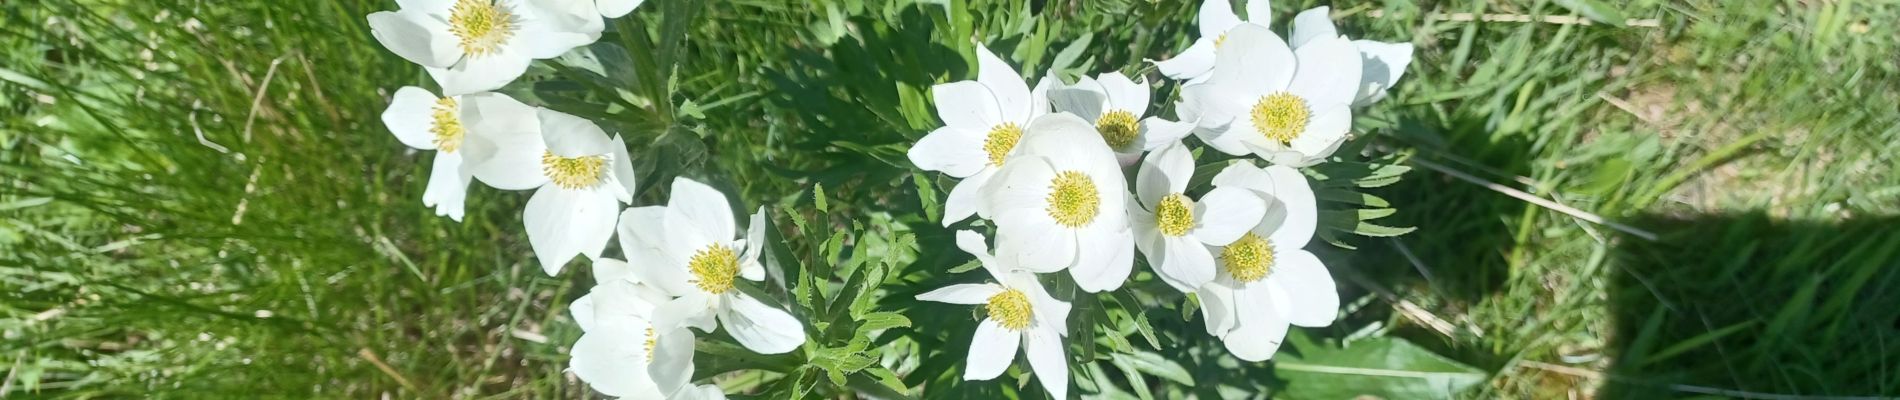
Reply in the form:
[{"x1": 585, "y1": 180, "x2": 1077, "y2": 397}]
[{"x1": 1598, "y1": 212, "x2": 1900, "y2": 398}]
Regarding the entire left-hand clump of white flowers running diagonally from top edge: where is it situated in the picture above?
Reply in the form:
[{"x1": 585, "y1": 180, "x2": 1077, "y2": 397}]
[{"x1": 369, "y1": 0, "x2": 801, "y2": 400}]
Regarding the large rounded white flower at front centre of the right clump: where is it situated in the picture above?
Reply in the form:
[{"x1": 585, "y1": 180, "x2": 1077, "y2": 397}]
[{"x1": 984, "y1": 112, "x2": 1134, "y2": 292}]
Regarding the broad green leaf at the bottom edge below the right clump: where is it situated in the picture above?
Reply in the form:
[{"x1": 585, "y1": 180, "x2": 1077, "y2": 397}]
[{"x1": 1273, "y1": 337, "x2": 1486, "y2": 398}]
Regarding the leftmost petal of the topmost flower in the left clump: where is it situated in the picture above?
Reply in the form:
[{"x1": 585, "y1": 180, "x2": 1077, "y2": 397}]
[{"x1": 369, "y1": 9, "x2": 462, "y2": 68}]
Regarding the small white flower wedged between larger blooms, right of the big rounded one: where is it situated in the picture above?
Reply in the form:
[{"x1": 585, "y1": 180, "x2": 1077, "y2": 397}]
[{"x1": 1129, "y1": 142, "x2": 1267, "y2": 292}]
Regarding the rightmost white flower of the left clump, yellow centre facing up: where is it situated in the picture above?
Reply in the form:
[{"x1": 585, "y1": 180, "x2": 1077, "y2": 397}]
[{"x1": 619, "y1": 178, "x2": 806, "y2": 355}]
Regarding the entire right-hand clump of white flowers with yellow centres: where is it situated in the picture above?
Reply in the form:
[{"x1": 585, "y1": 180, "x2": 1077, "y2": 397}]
[{"x1": 910, "y1": 0, "x2": 1412, "y2": 398}]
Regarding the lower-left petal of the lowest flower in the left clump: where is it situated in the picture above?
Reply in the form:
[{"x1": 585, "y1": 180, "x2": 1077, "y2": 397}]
[{"x1": 568, "y1": 324, "x2": 663, "y2": 396}]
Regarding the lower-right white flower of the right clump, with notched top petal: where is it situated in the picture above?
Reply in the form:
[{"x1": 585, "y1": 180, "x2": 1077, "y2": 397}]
[{"x1": 1199, "y1": 163, "x2": 1340, "y2": 362}]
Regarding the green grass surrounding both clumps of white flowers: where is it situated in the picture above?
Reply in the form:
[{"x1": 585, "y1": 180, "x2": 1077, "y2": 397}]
[{"x1": 0, "y1": 0, "x2": 1900, "y2": 398}]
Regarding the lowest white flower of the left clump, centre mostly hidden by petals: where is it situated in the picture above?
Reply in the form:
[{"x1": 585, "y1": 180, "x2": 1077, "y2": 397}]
[{"x1": 568, "y1": 258, "x2": 694, "y2": 398}]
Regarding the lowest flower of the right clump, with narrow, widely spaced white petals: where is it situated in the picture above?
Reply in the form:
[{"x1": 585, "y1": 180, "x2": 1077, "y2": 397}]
[{"x1": 918, "y1": 231, "x2": 1070, "y2": 398}]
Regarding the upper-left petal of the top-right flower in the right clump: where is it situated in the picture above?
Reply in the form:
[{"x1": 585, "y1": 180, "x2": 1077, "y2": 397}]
[{"x1": 1208, "y1": 23, "x2": 1299, "y2": 97}]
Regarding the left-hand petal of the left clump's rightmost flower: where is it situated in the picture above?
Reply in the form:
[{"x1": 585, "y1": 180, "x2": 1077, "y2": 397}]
[{"x1": 618, "y1": 205, "x2": 699, "y2": 296}]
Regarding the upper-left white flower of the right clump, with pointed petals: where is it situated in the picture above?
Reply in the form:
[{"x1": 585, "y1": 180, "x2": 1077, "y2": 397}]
[{"x1": 908, "y1": 44, "x2": 1053, "y2": 226}]
